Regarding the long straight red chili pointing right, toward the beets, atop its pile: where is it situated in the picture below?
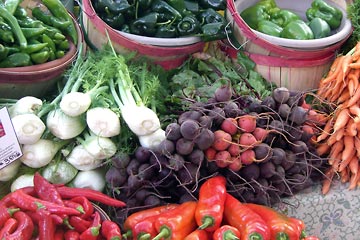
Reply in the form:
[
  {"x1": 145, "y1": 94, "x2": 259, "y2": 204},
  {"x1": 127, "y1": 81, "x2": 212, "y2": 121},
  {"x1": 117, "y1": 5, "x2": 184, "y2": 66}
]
[{"x1": 57, "y1": 186, "x2": 126, "y2": 207}]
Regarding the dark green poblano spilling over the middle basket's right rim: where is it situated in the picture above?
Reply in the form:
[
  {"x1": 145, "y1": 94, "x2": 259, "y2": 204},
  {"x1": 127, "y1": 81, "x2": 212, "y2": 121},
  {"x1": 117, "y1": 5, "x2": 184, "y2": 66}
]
[{"x1": 201, "y1": 22, "x2": 230, "y2": 42}]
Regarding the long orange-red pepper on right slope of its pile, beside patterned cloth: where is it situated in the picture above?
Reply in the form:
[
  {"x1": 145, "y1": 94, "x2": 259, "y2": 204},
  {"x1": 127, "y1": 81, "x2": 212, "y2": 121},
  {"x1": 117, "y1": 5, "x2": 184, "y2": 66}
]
[{"x1": 245, "y1": 203, "x2": 301, "y2": 240}]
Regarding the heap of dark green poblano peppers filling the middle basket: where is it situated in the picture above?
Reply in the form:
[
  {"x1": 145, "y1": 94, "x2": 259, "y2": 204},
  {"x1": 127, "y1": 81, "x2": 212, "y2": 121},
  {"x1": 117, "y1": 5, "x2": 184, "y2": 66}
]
[{"x1": 92, "y1": 0, "x2": 231, "y2": 42}]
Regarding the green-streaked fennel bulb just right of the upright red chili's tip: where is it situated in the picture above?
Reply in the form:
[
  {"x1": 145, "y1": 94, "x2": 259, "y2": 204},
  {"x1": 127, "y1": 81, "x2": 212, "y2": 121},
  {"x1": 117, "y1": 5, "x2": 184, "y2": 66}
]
[{"x1": 42, "y1": 160, "x2": 78, "y2": 184}]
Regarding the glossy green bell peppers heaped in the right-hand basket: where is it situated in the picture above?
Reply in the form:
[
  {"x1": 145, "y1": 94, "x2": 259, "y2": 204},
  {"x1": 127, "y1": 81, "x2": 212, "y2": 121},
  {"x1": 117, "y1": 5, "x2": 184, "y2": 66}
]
[{"x1": 240, "y1": 0, "x2": 343, "y2": 40}]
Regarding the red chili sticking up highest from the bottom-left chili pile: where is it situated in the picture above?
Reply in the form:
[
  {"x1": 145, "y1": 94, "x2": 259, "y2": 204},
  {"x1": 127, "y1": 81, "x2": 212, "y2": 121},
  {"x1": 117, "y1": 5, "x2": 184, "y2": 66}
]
[{"x1": 34, "y1": 172, "x2": 64, "y2": 205}]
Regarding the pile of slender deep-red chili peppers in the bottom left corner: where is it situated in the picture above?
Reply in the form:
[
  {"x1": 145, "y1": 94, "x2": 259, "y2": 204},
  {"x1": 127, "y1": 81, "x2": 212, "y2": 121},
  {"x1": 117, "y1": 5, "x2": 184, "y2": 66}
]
[{"x1": 0, "y1": 172, "x2": 125, "y2": 240}]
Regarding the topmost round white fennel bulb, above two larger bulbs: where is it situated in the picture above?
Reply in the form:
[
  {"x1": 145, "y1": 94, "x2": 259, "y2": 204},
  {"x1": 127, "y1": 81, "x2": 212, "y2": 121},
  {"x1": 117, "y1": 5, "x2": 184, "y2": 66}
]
[{"x1": 60, "y1": 92, "x2": 91, "y2": 117}]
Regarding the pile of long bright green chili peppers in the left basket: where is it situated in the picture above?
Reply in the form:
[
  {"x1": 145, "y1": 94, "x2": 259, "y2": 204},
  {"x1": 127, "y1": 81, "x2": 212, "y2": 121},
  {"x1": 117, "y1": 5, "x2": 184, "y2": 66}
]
[{"x1": 0, "y1": 0, "x2": 78, "y2": 68}]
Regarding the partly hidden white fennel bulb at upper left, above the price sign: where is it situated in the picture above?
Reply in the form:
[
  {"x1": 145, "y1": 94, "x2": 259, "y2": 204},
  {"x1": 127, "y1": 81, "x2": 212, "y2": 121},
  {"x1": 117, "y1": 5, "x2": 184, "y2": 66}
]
[{"x1": 9, "y1": 96, "x2": 43, "y2": 117}]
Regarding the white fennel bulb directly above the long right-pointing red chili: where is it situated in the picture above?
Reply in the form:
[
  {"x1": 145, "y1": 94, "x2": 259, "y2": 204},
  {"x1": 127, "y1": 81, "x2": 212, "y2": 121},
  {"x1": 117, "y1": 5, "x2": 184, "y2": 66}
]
[{"x1": 72, "y1": 168, "x2": 106, "y2": 192}]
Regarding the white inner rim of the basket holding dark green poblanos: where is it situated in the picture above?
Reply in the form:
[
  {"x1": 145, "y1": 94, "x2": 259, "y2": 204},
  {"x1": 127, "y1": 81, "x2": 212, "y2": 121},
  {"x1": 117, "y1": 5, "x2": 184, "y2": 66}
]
[{"x1": 117, "y1": 31, "x2": 201, "y2": 47}]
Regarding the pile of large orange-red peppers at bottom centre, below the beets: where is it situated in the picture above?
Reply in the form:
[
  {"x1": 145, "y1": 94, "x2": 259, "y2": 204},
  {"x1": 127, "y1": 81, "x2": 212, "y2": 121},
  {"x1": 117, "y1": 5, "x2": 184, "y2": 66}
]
[{"x1": 122, "y1": 175, "x2": 318, "y2": 240}]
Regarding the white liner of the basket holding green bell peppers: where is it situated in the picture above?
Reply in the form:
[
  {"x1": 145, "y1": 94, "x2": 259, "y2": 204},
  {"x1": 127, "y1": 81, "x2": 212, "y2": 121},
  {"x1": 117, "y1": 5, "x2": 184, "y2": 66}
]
[{"x1": 235, "y1": 0, "x2": 352, "y2": 49}]
